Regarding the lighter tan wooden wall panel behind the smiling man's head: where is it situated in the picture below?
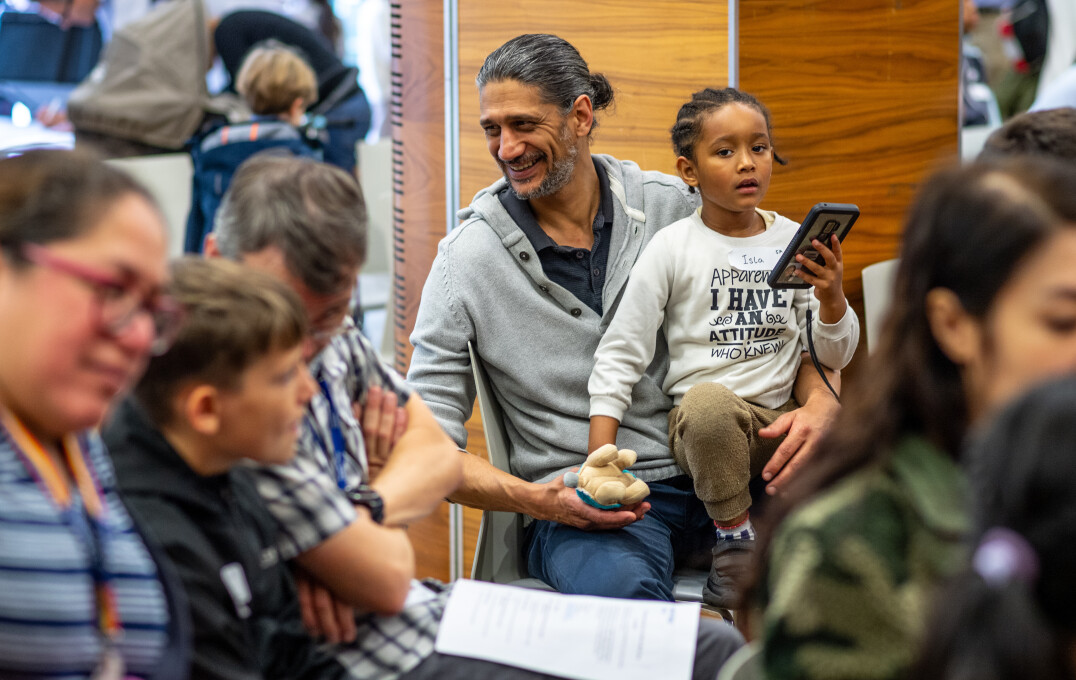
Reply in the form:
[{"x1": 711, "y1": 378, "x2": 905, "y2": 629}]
[{"x1": 459, "y1": 0, "x2": 728, "y2": 206}]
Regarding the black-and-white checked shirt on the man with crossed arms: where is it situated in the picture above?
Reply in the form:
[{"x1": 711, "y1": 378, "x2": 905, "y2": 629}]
[{"x1": 248, "y1": 318, "x2": 448, "y2": 680}]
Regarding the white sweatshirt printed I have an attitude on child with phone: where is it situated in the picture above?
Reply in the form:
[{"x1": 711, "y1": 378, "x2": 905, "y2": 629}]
[{"x1": 589, "y1": 210, "x2": 860, "y2": 421}]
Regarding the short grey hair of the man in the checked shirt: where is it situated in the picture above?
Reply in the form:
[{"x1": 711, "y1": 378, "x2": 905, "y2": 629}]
[{"x1": 214, "y1": 156, "x2": 366, "y2": 295}]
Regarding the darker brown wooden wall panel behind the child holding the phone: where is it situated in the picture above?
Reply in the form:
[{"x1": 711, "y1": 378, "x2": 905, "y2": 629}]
[{"x1": 738, "y1": 0, "x2": 960, "y2": 379}]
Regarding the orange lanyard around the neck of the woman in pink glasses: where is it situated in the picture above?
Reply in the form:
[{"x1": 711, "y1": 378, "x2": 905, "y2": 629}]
[{"x1": 0, "y1": 409, "x2": 123, "y2": 641}]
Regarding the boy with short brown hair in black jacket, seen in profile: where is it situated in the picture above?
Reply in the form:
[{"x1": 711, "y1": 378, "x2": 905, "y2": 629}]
[{"x1": 104, "y1": 259, "x2": 346, "y2": 679}]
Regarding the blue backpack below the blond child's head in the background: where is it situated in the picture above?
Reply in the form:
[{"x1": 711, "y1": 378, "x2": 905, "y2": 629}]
[{"x1": 183, "y1": 119, "x2": 322, "y2": 253}]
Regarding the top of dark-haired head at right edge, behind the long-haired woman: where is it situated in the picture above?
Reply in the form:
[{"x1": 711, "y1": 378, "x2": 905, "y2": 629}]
[{"x1": 979, "y1": 107, "x2": 1076, "y2": 162}]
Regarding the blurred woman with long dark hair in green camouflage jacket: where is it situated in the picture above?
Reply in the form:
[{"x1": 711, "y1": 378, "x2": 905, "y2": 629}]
[{"x1": 759, "y1": 159, "x2": 1076, "y2": 679}]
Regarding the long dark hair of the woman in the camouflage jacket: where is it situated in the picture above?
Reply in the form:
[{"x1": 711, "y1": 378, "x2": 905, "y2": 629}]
[{"x1": 774, "y1": 158, "x2": 1076, "y2": 488}]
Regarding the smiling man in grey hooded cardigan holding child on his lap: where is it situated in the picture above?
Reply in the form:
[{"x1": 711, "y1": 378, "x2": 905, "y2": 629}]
[{"x1": 408, "y1": 34, "x2": 837, "y2": 599}]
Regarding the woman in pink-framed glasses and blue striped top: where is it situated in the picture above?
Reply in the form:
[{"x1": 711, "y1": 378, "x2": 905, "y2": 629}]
[{"x1": 0, "y1": 151, "x2": 186, "y2": 679}]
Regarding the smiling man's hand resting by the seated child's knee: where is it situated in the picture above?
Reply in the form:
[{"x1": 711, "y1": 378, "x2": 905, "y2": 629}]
[{"x1": 759, "y1": 389, "x2": 840, "y2": 496}]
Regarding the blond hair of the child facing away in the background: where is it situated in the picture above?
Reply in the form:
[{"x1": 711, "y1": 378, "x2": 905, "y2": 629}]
[{"x1": 236, "y1": 42, "x2": 317, "y2": 115}]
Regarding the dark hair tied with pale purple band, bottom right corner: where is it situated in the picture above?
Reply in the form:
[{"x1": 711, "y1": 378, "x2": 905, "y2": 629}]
[{"x1": 909, "y1": 377, "x2": 1076, "y2": 680}]
